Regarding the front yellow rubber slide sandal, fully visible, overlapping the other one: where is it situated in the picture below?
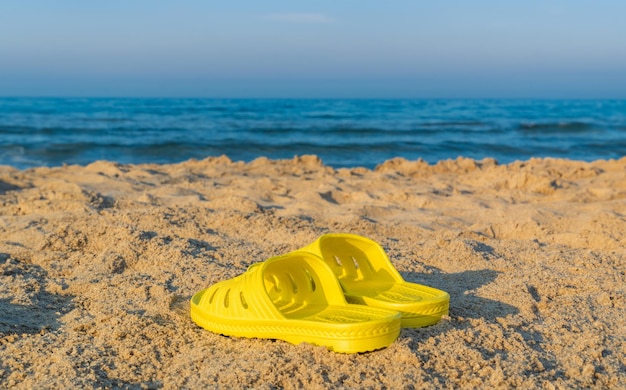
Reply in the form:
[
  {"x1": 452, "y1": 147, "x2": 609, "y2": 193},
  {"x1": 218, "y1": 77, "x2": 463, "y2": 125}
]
[{"x1": 191, "y1": 252, "x2": 401, "y2": 353}]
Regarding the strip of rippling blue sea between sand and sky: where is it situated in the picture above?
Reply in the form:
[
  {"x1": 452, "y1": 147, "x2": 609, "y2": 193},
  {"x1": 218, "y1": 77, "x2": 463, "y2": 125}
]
[{"x1": 0, "y1": 98, "x2": 626, "y2": 169}]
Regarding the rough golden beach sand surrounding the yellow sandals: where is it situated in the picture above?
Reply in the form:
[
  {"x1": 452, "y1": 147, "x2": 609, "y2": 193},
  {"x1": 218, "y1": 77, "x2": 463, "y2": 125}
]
[{"x1": 0, "y1": 156, "x2": 626, "y2": 389}]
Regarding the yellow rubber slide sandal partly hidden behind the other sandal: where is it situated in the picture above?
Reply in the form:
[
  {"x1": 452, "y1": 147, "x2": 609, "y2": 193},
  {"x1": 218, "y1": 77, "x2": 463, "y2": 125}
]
[{"x1": 300, "y1": 234, "x2": 450, "y2": 328}]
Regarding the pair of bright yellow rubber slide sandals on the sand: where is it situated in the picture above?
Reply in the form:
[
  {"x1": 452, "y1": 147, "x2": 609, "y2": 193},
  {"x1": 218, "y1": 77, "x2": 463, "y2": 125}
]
[{"x1": 191, "y1": 234, "x2": 450, "y2": 353}]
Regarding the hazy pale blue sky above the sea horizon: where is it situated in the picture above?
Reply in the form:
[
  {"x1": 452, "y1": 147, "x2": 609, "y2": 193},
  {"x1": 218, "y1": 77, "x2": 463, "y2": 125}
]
[{"x1": 0, "y1": 0, "x2": 626, "y2": 98}]
